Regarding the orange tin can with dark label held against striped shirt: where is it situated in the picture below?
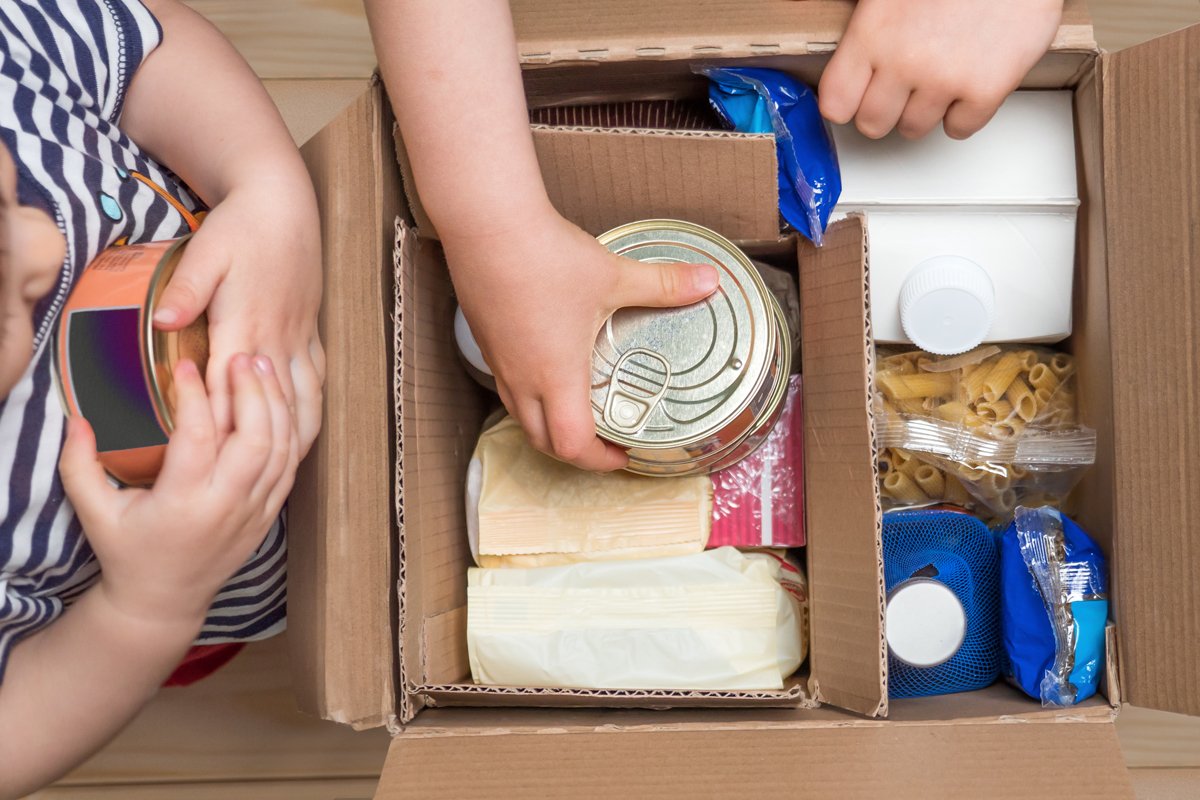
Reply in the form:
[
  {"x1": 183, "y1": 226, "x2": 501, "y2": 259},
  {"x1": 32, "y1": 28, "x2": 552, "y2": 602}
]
[{"x1": 54, "y1": 236, "x2": 208, "y2": 486}]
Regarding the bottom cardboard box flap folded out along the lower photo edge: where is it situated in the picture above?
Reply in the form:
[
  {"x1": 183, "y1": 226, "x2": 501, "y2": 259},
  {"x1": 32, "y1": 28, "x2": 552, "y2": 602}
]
[{"x1": 376, "y1": 715, "x2": 1134, "y2": 800}]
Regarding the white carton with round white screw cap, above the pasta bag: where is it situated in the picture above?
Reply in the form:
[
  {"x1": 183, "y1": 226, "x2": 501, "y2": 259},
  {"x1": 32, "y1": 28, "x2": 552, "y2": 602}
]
[{"x1": 834, "y1": 91, "x2": 1079, "y2": 355}]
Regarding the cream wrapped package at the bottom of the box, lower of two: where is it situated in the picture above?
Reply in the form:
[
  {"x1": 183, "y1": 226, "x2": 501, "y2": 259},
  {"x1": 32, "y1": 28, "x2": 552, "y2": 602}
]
[{"x1": 467, "y1": 547, "x2": 808, "y2": 690}]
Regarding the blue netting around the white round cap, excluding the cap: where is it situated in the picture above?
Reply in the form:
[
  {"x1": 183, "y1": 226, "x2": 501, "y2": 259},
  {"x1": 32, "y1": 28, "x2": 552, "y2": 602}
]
[{"x1": 883, "y1": 511, "x2": 1002, "y2": 698}]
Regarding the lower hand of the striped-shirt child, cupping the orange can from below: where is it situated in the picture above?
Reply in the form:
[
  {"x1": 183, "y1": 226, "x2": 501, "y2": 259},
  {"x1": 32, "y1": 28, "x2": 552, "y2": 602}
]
[{"x1": 59, "y1": 354, "x2": 300, "y2": 630}]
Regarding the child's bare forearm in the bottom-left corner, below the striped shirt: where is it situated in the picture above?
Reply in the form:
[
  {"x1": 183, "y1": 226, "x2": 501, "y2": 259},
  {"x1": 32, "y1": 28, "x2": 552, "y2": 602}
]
[{"x1": 0, "y1": 584, "x2": 202, "y2": 799}]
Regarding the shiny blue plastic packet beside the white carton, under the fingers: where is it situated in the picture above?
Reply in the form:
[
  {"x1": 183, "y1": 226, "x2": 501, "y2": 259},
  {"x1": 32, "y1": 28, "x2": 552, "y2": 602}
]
[{"x1": 696, "y1": 67, "x2": 841, "y2": 245}]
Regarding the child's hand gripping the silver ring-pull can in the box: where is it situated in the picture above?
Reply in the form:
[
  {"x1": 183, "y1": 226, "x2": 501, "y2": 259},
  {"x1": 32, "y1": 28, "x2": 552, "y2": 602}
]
[{"x1": 443, "y1": 211, "x2": 718, "y2": 471}]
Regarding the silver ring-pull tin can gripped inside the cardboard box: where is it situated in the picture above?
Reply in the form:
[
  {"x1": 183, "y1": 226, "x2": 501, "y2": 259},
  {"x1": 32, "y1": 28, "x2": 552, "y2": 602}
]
[{"x1": 592, "y1": 219, "x2": 792, "y2": 475}]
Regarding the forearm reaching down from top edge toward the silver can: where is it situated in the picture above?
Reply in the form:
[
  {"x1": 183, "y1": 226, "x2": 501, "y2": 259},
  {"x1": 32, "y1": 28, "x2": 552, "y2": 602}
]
[{"x1": 366, "y1": 0, "x2": 550, "y2": 239}]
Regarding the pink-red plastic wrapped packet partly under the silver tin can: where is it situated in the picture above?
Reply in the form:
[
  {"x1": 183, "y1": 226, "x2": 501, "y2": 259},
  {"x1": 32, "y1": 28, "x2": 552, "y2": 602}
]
[{"x1": 708, "y1": 375, "x2": 805, "y2": 547}]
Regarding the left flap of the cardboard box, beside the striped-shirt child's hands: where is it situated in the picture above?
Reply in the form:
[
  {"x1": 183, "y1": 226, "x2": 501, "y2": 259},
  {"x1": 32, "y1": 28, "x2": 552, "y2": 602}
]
[{"x1": 288, "y1": 84, "x2": 400, "y2": 727}]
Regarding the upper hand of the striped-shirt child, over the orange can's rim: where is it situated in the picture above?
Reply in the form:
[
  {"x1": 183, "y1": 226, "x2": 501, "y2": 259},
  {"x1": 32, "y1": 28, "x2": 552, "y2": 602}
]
[{"x1": 155, "y1": 184, "x2": 325, "y2": 455}]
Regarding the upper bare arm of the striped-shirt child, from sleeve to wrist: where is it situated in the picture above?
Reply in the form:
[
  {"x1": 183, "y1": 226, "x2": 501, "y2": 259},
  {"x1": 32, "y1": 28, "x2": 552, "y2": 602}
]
[{"x1": 121, "y1": 0, "x2": 312, "y2": 206}]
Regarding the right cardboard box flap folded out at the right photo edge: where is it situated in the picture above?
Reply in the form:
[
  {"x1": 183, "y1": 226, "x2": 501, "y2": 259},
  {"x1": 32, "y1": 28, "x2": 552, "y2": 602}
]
[{"x1": 1102, "y1": 26, "x2": 1200, "y2": 715}]
